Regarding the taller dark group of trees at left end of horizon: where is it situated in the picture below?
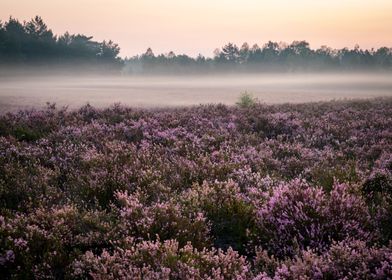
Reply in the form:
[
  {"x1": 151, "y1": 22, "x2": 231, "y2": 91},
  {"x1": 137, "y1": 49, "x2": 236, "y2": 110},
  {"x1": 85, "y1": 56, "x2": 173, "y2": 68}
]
[{"x1": 0, "y1": 16, "x2": 122, "y2": 66}]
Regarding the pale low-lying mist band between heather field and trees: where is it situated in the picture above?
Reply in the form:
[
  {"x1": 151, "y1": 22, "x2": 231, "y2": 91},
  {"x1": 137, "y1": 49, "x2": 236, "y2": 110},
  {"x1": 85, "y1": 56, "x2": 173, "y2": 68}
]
[{"x1": 0, "y1": 73, "x2": 392, "y2": 113}]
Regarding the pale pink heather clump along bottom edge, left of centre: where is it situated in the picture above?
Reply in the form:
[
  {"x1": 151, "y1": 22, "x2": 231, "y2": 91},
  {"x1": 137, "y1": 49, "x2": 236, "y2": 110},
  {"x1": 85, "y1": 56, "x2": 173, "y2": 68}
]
[{"x1": 73, "y1": 240, "x2": 251, "y2": 280}]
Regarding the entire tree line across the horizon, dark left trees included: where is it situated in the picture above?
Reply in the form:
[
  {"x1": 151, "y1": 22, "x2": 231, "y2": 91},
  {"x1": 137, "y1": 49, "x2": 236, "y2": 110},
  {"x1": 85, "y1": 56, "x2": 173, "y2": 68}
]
[{"x1": 0, "y1": 16, "x2": 392, "y2": 73}]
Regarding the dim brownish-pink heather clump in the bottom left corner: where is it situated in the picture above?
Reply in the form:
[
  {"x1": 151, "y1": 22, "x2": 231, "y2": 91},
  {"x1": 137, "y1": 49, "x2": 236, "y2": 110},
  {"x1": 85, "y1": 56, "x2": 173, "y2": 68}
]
[{"x1": 0, "y1": 206, "x2": 116, "y2": 278}]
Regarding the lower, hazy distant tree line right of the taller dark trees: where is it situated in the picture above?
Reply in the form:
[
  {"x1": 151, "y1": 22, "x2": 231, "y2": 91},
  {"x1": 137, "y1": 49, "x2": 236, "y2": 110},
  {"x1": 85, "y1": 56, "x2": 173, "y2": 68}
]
[{"x1": 125, "y1": 41, "x2": 392, "y2": 73}]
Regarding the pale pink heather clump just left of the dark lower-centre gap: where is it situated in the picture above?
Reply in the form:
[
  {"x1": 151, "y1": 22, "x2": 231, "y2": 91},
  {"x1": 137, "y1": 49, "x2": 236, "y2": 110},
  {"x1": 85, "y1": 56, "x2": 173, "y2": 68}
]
[{"x1": 116, "y1": 190, "x2": 211, "y2": 249}]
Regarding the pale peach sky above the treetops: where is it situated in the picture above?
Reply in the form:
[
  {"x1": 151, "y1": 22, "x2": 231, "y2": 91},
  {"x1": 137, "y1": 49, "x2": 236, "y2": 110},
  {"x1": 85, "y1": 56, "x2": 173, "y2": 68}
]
[{"x1": 0, "y1": 0, "x2": 392, "y2": 56}]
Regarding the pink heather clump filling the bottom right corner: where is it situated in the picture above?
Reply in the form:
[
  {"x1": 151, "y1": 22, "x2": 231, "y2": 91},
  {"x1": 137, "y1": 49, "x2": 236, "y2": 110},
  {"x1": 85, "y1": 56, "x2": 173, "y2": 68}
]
[{"x1": 270, "y1": 240, "x2": 392, "y2": 280}]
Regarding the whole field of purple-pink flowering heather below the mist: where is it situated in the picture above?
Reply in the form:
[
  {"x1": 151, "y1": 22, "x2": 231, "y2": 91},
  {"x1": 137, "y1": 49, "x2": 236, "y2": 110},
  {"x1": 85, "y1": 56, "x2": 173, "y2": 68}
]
[{"x1": 0, "y1": 98, "x2": 392, "y2": 280}]
